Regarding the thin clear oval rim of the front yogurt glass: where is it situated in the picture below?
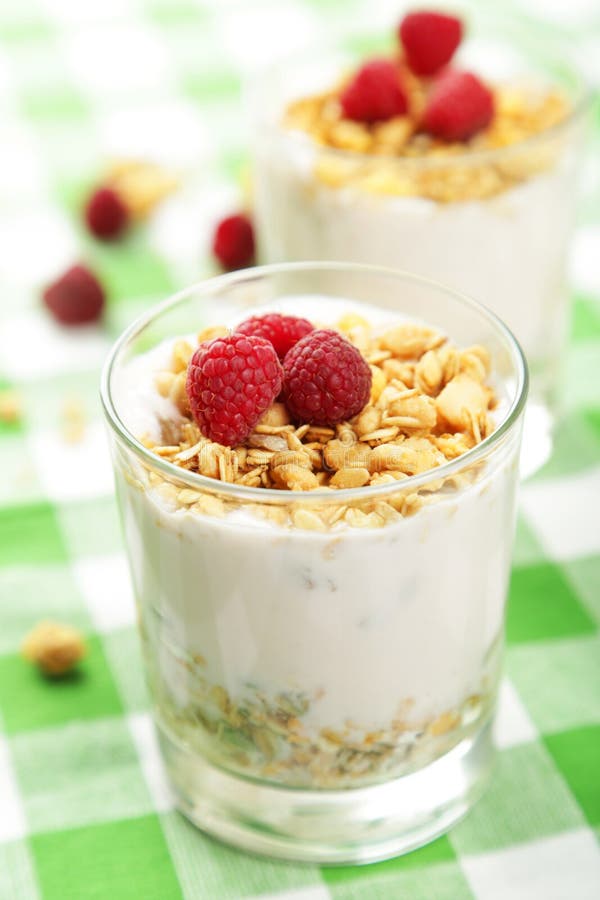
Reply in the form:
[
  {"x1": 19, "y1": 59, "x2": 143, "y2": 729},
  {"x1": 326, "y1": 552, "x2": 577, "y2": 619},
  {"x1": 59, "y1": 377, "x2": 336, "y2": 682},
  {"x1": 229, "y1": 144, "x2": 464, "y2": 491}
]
[{"x1": 100, "y1": 261, "x2": 529, "y2": 505}]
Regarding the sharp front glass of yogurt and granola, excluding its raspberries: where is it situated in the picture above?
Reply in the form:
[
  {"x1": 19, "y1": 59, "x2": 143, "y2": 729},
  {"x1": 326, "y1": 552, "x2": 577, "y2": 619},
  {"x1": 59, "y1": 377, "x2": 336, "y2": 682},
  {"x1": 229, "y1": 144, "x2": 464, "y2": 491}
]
[{"x1": 102, "y1": 263, "x2": 527, "y2": 863}]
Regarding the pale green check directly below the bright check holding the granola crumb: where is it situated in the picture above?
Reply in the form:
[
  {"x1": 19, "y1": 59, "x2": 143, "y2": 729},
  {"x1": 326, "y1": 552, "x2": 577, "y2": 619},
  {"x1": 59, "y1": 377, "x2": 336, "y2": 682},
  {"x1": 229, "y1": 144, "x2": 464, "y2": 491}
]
[{"x1": 10, "y1": 717, "x2": 152, "y2": 832}]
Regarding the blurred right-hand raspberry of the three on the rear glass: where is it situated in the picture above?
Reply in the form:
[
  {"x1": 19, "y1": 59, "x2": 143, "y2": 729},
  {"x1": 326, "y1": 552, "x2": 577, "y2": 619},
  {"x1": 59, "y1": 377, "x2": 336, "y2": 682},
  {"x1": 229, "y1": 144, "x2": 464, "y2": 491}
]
[{"x1": 421, "y1": 70, "x2": 494, "y2": 141}]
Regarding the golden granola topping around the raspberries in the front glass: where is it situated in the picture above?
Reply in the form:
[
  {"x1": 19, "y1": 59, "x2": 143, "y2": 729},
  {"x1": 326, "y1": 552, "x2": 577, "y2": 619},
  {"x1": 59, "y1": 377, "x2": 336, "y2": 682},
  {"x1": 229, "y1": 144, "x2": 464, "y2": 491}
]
[{"x1": 148, "y1": 314, "x2": 496, "y2": 530}]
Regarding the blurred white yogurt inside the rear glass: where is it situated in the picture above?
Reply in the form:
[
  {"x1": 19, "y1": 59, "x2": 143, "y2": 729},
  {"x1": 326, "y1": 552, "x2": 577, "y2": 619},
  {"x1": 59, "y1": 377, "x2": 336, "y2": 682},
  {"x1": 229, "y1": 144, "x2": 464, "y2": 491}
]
[{"x1": 255, "y1": 136, "x2": 576, "y2": 381}]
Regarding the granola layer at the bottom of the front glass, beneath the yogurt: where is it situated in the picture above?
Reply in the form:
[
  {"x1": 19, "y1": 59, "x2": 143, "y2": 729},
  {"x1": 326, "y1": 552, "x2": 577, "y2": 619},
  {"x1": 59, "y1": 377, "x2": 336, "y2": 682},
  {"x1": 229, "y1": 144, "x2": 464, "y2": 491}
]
[{"x1": 146, "y1": 636, "x2": 501, "y2": 789}]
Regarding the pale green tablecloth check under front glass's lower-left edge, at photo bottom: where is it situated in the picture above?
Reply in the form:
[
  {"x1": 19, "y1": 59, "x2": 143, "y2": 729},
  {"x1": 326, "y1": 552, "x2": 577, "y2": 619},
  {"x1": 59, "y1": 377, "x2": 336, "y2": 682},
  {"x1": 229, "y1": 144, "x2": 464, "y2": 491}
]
[{"x1": 161, "y1": 812, "x2": 321, "y2": 900}]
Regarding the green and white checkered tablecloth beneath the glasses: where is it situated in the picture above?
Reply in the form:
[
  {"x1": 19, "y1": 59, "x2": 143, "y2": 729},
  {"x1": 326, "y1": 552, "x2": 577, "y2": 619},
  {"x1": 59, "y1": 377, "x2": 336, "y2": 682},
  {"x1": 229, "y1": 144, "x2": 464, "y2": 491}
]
[{"x1": 0, "y1": 0, "x2": 600, "y2": 900}]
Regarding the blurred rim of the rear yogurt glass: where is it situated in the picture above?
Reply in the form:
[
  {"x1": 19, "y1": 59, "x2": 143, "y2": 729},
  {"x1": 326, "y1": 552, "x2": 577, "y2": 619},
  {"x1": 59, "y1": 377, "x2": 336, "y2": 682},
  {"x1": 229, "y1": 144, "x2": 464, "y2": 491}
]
[{"x1": 253, "y1": 51, "x2": 595, "y2": 169}]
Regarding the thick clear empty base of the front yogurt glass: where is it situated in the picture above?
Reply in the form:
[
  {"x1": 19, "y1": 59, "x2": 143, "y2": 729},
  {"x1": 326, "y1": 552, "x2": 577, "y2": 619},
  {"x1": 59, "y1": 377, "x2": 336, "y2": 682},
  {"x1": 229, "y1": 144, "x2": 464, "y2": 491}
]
[{"x1": 158, "y1": 721, "x2": 494, "y2": 864}]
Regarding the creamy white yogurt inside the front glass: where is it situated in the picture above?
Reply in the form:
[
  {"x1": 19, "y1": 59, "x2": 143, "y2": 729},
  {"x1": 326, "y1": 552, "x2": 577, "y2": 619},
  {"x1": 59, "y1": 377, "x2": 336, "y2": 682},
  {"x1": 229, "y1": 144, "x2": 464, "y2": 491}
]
[{"x1": 115, "y1": 302, "x2": 518, "y2": 780}]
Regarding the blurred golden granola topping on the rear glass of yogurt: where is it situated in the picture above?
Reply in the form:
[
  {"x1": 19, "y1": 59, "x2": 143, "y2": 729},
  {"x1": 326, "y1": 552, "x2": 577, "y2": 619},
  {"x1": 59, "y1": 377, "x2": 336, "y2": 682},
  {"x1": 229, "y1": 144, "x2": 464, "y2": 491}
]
[{"x1": 283, "y1": 81, "x2": 569, "y2": 203}]
